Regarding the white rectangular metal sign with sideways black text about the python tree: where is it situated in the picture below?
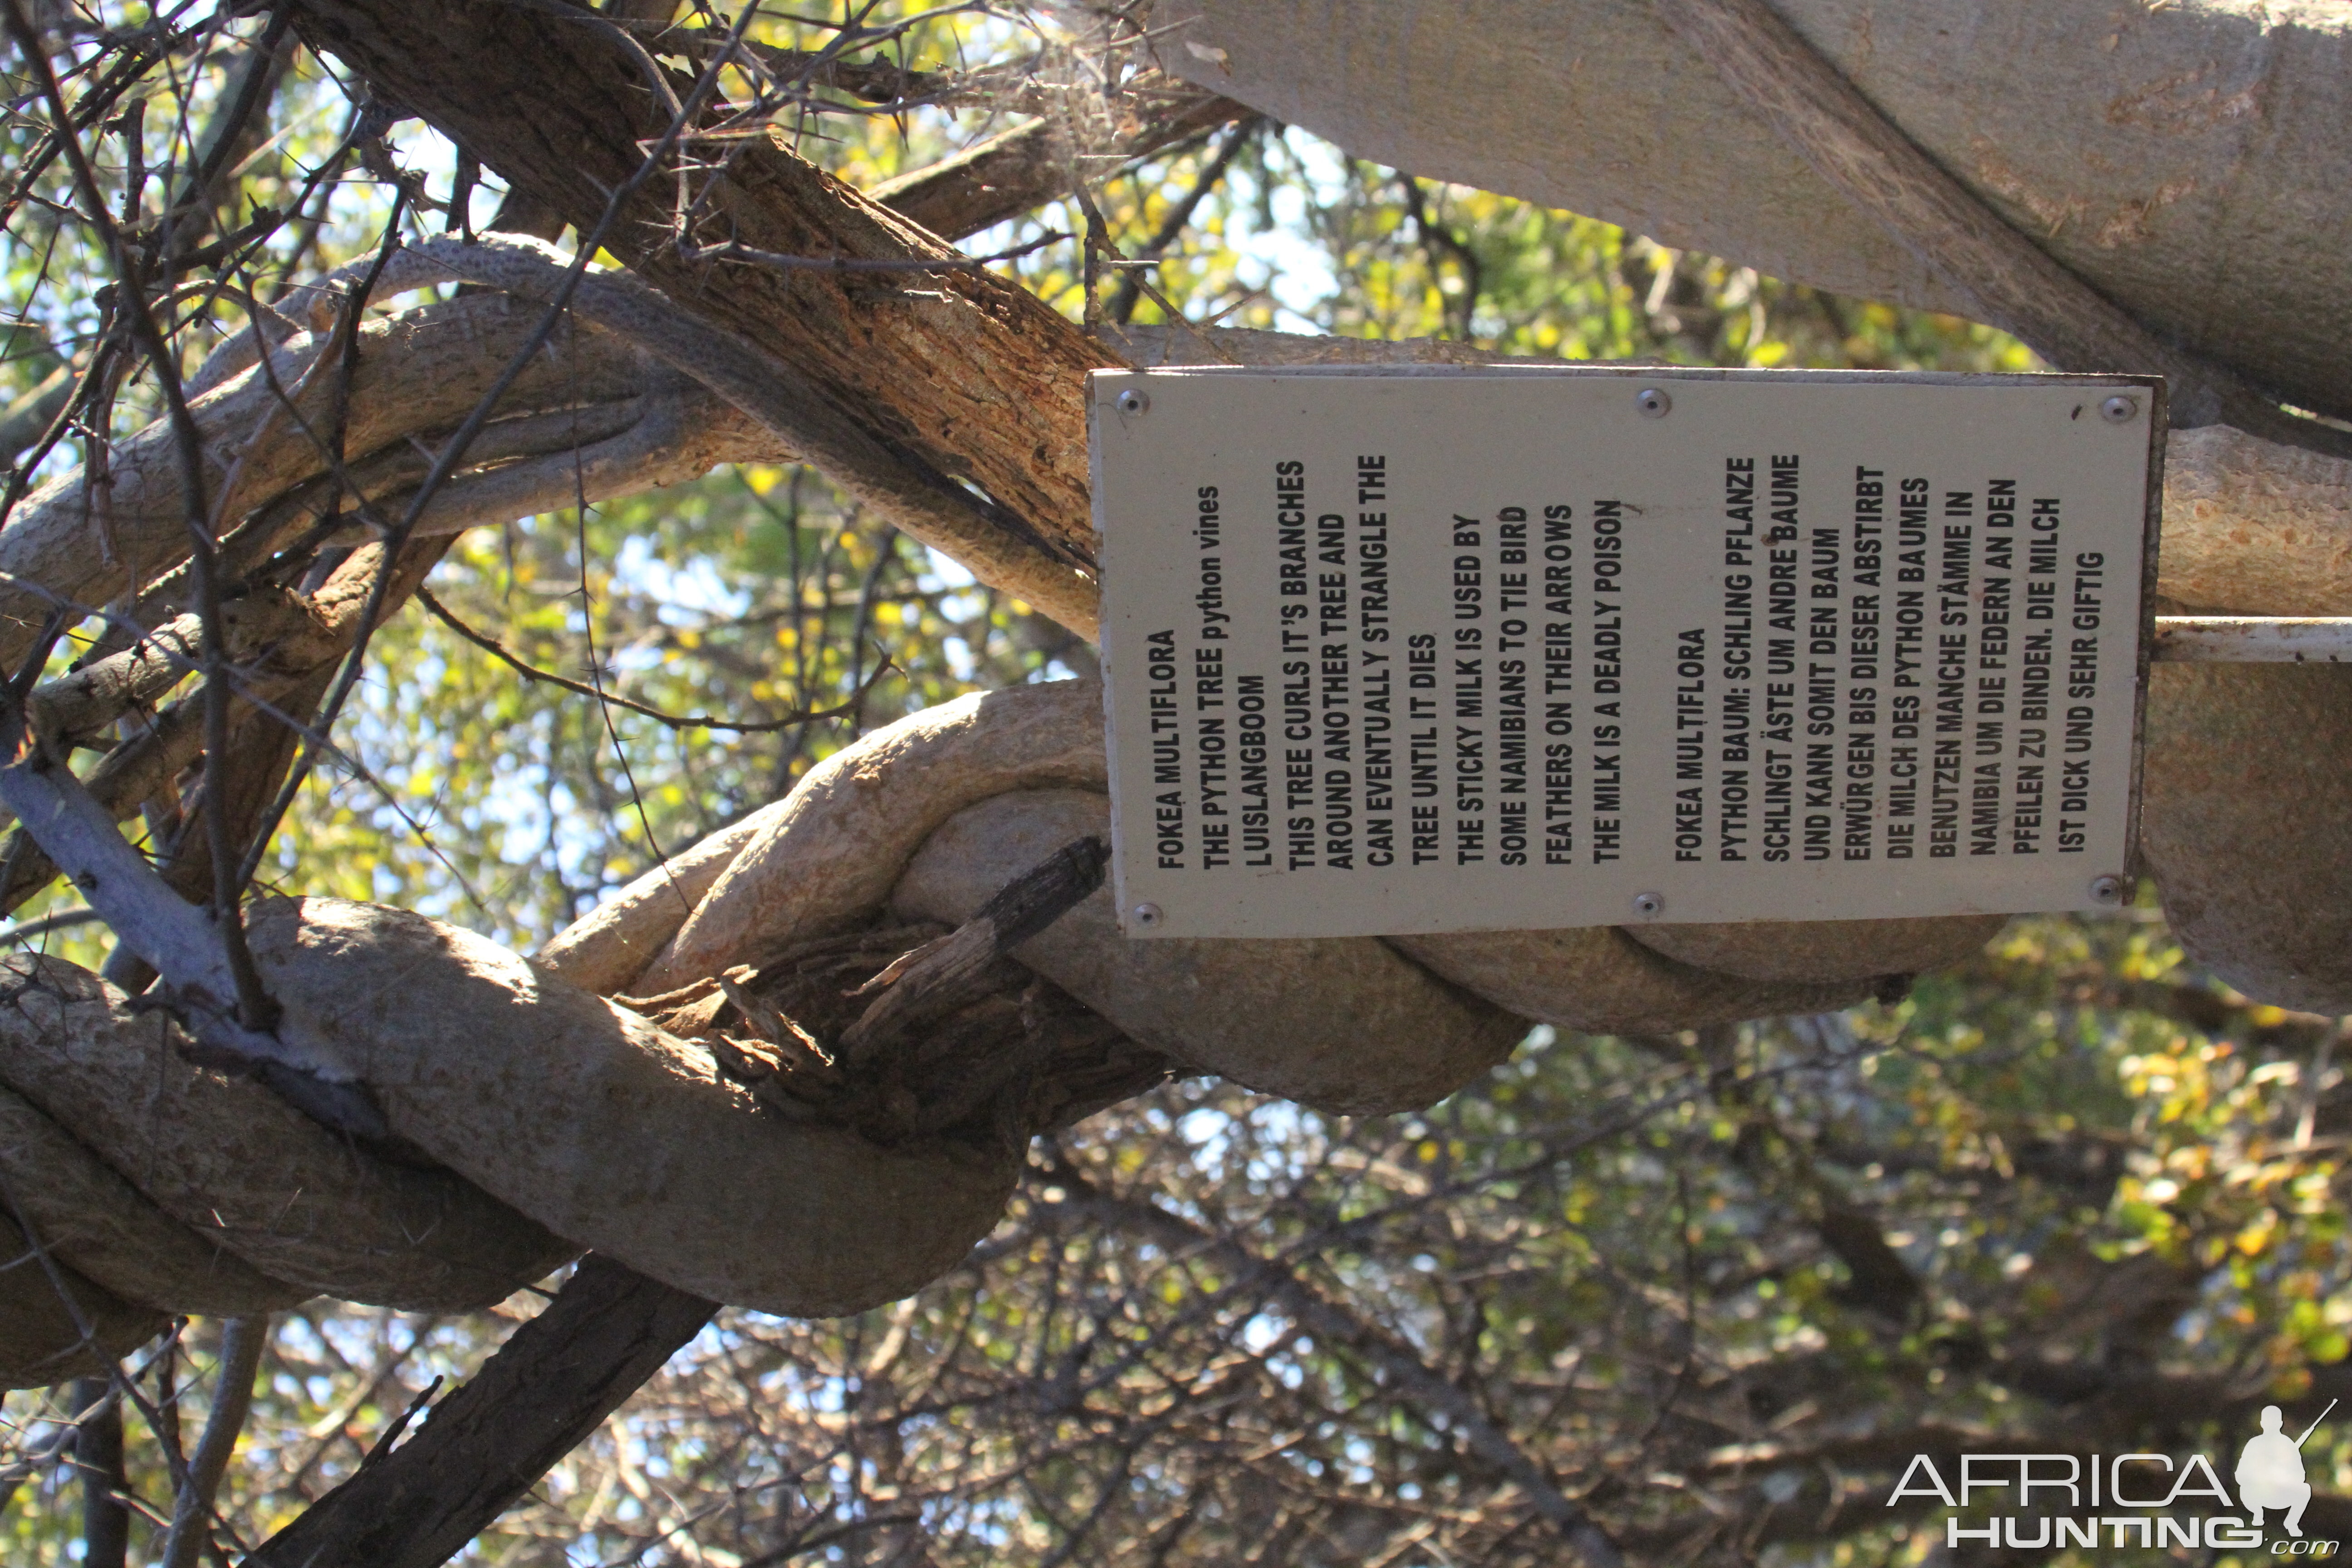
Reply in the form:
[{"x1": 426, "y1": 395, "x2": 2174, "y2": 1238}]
[{"x1": 1091, "y1": 367, "x2": 2161, "y2": 936}]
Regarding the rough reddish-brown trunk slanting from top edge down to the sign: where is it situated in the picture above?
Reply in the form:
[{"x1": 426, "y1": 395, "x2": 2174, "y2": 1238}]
[{"x1": 296, "y1": 0, "x2": 1115, "y2": 630}]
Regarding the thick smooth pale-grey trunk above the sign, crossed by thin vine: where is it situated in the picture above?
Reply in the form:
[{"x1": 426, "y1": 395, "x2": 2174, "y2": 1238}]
[{"x1": 1152, "y1": 0, "x2": 2352, "y2": 414}]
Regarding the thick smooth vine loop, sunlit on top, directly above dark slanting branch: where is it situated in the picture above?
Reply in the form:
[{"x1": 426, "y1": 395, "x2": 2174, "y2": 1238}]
[{"x1": 250, "y1": 898, "x2": 1021, "y2": 1317}]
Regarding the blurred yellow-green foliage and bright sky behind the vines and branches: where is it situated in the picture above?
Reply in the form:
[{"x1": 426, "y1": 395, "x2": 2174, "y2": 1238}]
[{"x1": 0, "y1": 0, "x2": 2352, "y2": 1568}]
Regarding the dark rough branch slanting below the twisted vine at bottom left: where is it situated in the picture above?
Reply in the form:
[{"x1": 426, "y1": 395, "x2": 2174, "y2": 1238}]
[{"x1": 247, "y1": 1253, "x2": 717, "y2": 1568}]
